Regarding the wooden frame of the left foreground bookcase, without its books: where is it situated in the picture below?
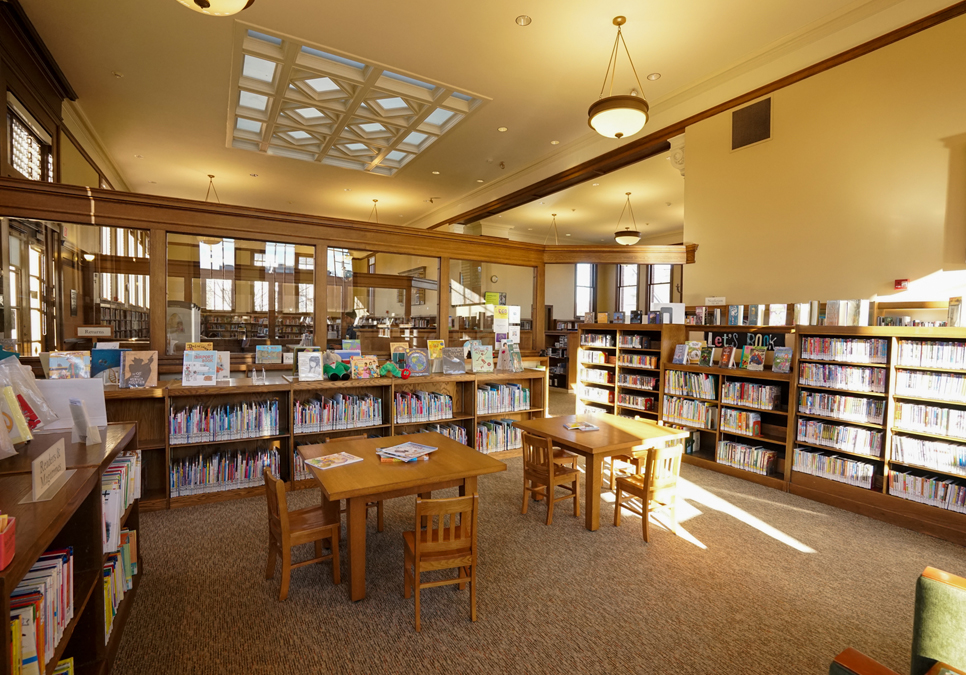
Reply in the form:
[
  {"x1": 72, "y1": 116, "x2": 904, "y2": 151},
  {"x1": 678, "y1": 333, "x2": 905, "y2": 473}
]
[{"x1": 0, "y1": 424, "x2": 144, "y2": 675}]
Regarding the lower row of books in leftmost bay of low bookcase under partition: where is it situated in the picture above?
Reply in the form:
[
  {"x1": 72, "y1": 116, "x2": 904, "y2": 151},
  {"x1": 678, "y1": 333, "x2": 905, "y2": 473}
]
[{"x1": 171, "y1": 448, "x2": 279, "y2": 497}]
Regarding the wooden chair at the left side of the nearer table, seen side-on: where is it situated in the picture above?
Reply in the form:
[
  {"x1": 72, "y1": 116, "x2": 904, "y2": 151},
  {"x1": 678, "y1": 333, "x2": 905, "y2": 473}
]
[{"x1": 263, "y1": 468, "x2": 341, "y2": 600}]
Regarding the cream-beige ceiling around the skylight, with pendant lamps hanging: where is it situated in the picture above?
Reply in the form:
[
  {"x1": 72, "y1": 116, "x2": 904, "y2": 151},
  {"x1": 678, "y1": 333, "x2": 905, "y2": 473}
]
[{"x1": 21, "y1": 0, "x2": 948, "y2": 238}]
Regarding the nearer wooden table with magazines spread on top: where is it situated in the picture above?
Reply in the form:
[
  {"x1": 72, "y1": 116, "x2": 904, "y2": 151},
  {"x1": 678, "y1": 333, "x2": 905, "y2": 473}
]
[{"x1": 298, "y1": 432, "x2": 506, "y2": 600}]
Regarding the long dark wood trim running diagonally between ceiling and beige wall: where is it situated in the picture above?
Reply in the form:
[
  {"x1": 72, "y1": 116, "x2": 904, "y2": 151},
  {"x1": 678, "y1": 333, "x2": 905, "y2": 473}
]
[{"x1": 427, "y1": 1, "x2": 966, "y2": 230}]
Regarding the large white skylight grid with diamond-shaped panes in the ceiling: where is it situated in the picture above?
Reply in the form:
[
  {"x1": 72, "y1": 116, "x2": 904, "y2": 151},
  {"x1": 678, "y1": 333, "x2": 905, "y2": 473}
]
[{"x1": 229, "y1": 29, "x2": 484, "y2": 176}]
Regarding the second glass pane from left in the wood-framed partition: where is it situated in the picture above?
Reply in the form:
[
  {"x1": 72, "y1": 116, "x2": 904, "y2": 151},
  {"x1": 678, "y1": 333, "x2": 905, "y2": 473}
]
[{"x1": 165, "y1": 234, "x2": 315, "y2": 354}]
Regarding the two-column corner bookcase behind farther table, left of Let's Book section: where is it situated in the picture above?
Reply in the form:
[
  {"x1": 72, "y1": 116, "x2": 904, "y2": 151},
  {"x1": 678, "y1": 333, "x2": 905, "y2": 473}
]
[{"x1": 577, "y1": 323, "x2": 684, "y2": 421}]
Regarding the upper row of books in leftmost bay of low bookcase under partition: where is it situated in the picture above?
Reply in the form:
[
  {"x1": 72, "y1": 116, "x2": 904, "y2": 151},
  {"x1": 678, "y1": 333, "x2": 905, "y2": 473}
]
[{"x1": 168, "y1": 398, "x2": 280, "y2": 445}]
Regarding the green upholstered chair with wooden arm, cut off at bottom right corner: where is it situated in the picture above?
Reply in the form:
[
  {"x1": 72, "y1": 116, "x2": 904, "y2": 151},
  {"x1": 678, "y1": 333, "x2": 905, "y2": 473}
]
[{"x1": 829, "y1": 567, "x2": 966, "y2": 675}]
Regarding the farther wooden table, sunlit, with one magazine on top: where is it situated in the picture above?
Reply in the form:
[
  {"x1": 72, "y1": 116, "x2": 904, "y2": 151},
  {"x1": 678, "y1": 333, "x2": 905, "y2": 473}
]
[{"x1": 513, "y1": 413, "x2": 688, "y2": 531}]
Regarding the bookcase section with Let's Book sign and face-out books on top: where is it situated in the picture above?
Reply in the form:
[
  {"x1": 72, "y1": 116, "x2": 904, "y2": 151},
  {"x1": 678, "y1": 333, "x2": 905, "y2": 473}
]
[{"x1": 661, "y1": 326, "x2": 795, "y2": 489}]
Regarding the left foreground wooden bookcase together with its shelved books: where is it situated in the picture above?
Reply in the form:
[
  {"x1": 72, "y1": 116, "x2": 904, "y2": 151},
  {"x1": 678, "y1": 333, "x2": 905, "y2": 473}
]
[{"x1": 0, "y1": 426, "x2": 144, "y2": 675}]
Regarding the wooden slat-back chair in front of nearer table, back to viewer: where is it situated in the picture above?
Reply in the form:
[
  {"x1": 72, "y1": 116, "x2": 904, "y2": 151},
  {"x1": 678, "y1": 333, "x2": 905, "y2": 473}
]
[{"x1": 403, "y1": 492, "x2": 480, "y2": 632}]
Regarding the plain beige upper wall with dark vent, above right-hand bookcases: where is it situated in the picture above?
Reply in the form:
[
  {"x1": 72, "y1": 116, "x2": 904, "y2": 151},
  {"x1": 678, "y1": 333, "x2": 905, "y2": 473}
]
[{"x1": 684, "y1": 17, "x2": 966, "y2": 304}]
